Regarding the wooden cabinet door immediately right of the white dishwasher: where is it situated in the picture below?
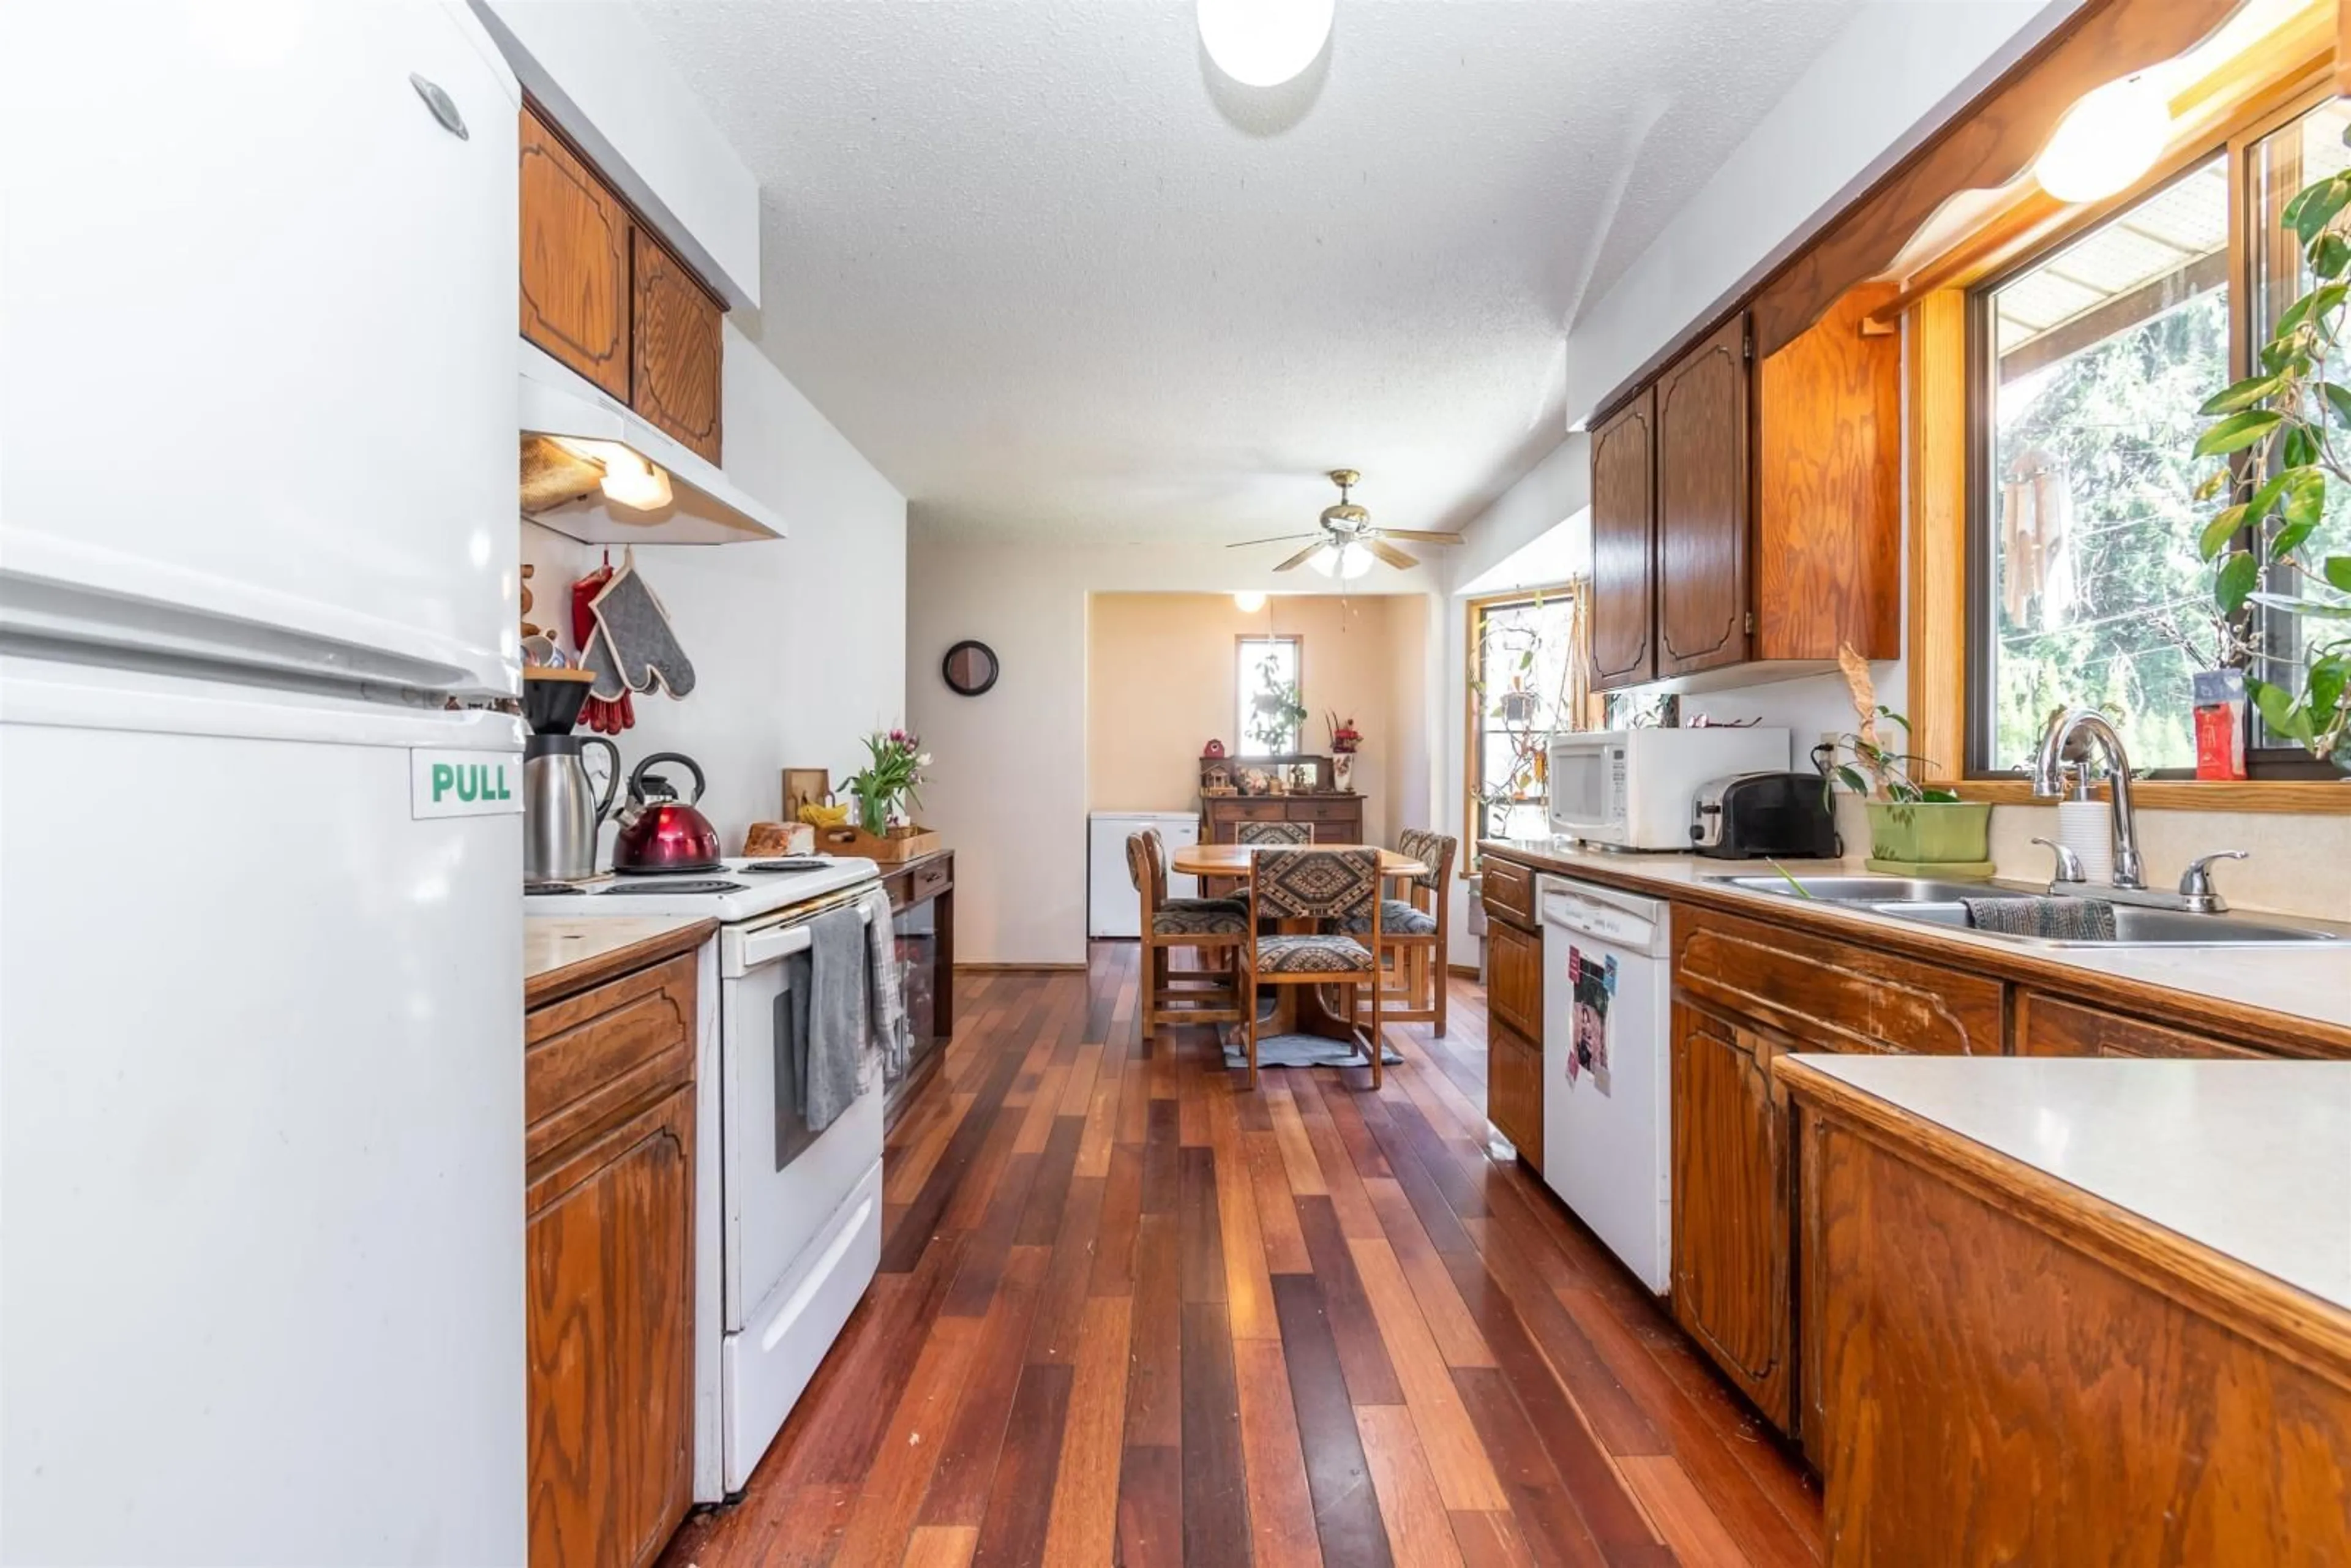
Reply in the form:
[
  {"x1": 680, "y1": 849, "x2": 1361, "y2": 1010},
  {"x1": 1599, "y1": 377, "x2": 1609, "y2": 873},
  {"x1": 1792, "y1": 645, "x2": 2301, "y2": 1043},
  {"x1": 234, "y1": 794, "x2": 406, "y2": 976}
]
[{"x1": 1671, "y1": 1004, "x2": 1794, "y2": 1429}]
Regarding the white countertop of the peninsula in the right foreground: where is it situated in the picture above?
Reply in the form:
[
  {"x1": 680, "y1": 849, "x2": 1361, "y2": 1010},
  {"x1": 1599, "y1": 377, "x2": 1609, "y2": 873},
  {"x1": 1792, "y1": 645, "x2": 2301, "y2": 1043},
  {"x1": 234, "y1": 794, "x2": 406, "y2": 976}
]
[{"x1": 1796, "y1": 1053, "x2": 2351, "y2": 1310}]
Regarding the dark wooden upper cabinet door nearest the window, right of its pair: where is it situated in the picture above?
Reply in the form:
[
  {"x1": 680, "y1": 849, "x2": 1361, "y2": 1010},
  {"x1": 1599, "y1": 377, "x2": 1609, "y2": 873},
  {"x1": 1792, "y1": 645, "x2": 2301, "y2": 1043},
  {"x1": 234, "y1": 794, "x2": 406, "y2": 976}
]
[{"x1": 1655, "y1": 315, "x2": 1752, "y2": 677}]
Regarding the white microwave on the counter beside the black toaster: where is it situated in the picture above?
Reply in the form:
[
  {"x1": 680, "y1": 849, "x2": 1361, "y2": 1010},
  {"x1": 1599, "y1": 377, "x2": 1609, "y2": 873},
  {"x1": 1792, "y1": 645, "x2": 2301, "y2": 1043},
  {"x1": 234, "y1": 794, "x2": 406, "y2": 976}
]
[{"x1": 1550, "y1": 726, "x2": 1789, "y2": 849}]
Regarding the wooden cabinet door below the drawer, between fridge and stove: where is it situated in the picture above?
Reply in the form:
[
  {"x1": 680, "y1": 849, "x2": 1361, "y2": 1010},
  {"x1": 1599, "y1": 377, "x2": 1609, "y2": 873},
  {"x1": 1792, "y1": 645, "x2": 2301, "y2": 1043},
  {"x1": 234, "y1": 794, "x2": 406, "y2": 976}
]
[{"x1": 538, "y1": 1086, "x2": 694, "y2": 1568}]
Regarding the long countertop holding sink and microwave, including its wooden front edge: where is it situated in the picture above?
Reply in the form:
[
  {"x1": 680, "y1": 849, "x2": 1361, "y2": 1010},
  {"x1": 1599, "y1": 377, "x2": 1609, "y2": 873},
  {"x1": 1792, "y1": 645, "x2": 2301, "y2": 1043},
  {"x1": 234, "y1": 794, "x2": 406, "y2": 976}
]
[{"x1": 1479, "y1": 839, "x2": 2351, "y2": 1060}]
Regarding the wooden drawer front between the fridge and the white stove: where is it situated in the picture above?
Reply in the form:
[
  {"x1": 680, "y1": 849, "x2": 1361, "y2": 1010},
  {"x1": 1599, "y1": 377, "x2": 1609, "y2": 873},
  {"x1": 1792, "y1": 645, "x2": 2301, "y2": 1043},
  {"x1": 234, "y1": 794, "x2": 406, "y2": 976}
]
[{"x1": 522, "y1": 952, "x2": 694, "y2": 1161}]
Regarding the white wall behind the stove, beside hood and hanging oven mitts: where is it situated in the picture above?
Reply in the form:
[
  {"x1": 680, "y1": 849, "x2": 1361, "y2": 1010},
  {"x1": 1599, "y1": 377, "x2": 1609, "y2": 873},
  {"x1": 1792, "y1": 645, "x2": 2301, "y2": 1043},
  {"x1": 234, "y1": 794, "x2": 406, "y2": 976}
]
[{"x1": 522, "y1": 322, "x2": 907, "y2": 853}]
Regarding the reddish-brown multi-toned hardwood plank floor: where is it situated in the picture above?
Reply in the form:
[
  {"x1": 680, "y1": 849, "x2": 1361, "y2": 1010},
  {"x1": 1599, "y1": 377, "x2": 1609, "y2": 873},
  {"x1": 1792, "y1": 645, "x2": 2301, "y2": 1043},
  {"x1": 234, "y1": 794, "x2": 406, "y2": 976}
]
[{"x1": 666, "y1": 943, "x2": 1820, "y2": 1568}]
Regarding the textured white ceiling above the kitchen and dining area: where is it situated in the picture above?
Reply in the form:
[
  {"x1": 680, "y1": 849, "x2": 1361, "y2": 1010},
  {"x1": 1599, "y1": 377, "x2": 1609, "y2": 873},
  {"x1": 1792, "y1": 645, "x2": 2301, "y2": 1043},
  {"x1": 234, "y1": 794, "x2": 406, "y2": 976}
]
[{"x1": 639, "y1": 0, "x2": 1858, "y2": 541}]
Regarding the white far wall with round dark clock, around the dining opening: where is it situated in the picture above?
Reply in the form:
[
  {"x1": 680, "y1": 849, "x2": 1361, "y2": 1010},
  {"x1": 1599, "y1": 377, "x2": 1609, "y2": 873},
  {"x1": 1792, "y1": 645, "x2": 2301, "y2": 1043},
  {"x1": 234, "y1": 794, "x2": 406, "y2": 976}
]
[{"x1": 905, "y1": 527, "x2": 1436, "y2": 964}]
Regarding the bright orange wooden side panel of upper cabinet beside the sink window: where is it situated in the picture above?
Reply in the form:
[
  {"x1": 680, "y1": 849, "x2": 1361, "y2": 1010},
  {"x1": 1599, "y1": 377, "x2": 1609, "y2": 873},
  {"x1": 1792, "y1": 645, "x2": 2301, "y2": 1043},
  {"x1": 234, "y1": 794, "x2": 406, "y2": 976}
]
[{"x1": 1754, "y1": 285, "x2": 1902, "y2": 658}]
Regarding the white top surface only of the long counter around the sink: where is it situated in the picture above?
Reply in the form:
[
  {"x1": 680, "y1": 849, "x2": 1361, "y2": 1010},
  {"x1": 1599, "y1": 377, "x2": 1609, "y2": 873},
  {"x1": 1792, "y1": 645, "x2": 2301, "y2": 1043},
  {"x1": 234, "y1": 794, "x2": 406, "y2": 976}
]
[{"x1": 1502, "y1": 839, "x2": 2351, "y2": 1048}]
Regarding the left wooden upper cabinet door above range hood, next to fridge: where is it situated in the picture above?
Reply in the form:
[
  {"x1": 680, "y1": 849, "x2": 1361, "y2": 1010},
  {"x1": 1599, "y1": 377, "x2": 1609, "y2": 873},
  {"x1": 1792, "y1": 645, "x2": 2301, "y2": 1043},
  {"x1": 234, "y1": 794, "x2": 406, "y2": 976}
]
[{"x1": 522, "y1": 108, "x2": 635, "y2": 400}]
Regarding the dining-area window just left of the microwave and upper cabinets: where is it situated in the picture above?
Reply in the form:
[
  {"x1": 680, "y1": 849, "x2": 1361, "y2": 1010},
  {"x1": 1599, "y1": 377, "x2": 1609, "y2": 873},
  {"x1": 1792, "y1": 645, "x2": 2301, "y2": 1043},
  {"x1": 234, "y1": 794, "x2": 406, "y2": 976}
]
[{"x1": 1464, "y1": 585, "x2": 1589, "y2": 844}]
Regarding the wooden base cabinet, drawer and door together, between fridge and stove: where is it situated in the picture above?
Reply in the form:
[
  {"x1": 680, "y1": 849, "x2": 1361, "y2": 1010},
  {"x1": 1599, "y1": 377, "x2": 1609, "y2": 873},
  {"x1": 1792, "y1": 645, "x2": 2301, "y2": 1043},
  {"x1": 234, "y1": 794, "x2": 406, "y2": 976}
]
[{"x1": 522, "y1": 952, "x2": 696, "y2": 1568}]
